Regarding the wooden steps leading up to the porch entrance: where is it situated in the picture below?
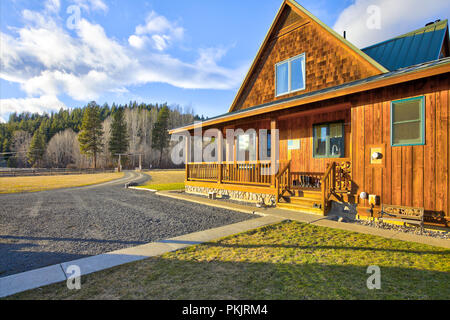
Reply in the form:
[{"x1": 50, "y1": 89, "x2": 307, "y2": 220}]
[{"x1": 277, "y1": 190, "x2": 323, "y2": 215}]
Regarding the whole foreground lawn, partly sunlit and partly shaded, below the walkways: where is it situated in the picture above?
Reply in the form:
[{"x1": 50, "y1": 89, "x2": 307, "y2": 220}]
[{"x1": 7, "y1": 221, "x2": 450, "y2": 299}]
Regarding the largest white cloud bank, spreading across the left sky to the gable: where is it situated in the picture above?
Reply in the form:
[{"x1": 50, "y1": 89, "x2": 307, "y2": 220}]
[{"x1": 0, "y1": 5, "x2": 247, "y2": 115}]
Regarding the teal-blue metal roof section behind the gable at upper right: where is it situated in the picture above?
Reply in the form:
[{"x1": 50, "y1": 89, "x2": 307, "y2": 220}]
[{"x1": 362, "y1": 20, "x2": 448, "y2": 71}]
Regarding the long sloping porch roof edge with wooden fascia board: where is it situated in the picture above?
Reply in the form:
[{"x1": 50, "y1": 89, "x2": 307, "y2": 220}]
[{"x1": 169, "y1": 57, "x2": 450, "y2": 134}]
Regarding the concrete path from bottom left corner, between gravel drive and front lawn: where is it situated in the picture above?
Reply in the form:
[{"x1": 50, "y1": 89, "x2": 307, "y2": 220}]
[{"x1": 0, "y1": 215, "x2": 283, "y2": 298}]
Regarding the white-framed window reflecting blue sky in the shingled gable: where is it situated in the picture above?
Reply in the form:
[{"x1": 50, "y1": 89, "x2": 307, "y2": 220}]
[{"x1": 275, "y1": 53, "x2": 305, "y2": 96}]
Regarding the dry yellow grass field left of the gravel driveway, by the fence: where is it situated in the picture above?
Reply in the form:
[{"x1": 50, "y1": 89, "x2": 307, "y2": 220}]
[{"x1": 0, "y1": 172, "x2": 124, "y2": 193}]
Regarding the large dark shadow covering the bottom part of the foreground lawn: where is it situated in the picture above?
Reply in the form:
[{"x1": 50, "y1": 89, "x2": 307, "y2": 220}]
[{"x1": 10, "y1": 257, "x2": 450, "y2": 300}]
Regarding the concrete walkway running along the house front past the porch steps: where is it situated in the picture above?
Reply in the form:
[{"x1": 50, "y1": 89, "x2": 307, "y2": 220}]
[{"x1": 157, "y1": 191, "x2": 450, "y2": 248}]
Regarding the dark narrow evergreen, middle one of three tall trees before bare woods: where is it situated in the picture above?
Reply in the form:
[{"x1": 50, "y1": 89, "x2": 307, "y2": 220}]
[{"x1": 109, "y1": 108, "x2": 129, "y2": 158}]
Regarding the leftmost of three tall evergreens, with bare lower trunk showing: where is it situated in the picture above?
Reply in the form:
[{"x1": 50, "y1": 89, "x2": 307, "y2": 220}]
[{"x1": 78, "y1": 102, "x2": 103, "y2": 168}]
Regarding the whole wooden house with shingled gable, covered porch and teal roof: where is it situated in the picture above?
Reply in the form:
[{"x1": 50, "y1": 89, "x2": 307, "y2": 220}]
[{"x1": 170, "y1": 0, "x2": 450, "y2": 226}]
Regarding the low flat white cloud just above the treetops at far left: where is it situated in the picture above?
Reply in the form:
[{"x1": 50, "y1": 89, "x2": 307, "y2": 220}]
[{"x1": 0, "y1": 96, "x2": 67, "y2": 122}]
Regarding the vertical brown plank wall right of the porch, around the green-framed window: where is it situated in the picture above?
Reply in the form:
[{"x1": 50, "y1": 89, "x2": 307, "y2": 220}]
[{"x1": 351, "y1": 75, "x2": 450, "y2": 225}]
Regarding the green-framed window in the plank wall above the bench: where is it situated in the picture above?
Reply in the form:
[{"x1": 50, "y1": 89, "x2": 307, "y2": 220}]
[{"x1": 391, "y1": 97, "x2": 425, "y2": 146}]
